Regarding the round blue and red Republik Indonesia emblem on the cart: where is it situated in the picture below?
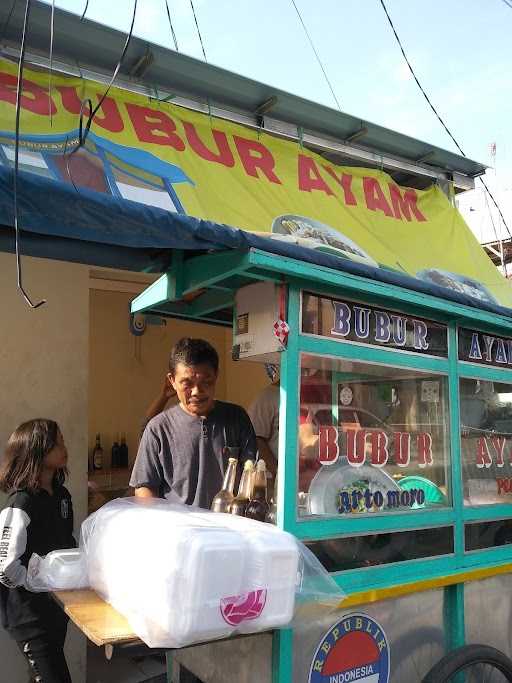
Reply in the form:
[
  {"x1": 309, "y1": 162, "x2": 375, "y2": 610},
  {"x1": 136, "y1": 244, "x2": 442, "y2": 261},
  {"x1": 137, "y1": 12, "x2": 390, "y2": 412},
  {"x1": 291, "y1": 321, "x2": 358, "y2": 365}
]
[{"x1": 308, "y1": 612, "x2": 390, "y2": 683}]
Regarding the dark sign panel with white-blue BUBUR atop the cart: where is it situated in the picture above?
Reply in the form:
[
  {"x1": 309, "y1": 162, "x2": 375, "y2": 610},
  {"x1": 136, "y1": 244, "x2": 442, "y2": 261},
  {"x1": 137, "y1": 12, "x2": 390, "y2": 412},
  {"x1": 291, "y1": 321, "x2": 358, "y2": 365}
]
[{"x1": 302, "y1": 293, "x2": 448, "y2": 357}]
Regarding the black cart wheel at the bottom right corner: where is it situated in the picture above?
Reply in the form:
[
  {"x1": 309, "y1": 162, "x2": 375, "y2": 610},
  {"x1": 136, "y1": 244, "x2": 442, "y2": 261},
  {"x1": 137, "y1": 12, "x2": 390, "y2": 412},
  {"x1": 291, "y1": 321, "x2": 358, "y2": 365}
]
[{"x1": 422, "y1": 645, "x2": 512, "y2": 683}]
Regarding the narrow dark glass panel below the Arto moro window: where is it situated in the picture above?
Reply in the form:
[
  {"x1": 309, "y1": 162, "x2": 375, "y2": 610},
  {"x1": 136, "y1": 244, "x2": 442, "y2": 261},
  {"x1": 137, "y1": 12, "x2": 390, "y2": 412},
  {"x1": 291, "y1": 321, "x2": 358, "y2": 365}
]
[{"x1": 306, "y1": 527, "x2": 453, "y2": 572}]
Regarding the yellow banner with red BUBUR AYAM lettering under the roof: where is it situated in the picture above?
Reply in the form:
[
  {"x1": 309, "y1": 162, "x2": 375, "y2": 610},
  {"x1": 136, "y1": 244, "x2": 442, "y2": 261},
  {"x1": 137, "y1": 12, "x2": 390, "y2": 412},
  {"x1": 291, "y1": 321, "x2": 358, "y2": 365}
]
[{"x1": 0, "y1": 60, "x2": 512, "y2": 307}]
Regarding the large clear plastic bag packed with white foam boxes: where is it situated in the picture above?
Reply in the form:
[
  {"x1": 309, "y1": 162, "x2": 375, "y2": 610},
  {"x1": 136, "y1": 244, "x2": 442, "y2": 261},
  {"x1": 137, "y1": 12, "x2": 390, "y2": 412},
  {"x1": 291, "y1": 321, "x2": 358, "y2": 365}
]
[{"x1": 80, "y1": 498, "x2": 343, "y2": 648}]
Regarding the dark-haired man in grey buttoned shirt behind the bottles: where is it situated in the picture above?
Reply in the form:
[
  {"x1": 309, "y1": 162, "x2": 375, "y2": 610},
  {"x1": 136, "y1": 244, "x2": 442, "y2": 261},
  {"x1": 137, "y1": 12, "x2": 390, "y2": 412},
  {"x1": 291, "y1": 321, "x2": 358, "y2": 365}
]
[{"x1": 130, "y1": 337, "x2": 256, "y2": 509}]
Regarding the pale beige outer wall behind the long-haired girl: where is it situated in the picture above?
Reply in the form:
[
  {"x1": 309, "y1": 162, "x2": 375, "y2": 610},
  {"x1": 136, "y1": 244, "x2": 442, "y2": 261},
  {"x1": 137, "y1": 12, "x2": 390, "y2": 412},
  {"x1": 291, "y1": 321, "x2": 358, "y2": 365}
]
[{"x1": 0, "y1": 253, "x2": 89, "y2": 683}]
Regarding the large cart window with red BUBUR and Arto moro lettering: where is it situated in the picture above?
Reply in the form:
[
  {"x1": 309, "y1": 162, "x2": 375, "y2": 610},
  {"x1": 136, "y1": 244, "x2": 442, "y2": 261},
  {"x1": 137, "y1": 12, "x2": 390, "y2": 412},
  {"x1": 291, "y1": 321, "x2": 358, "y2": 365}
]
[{"x1": 298, "y1": 354, "x2": 451, "y2": 516}]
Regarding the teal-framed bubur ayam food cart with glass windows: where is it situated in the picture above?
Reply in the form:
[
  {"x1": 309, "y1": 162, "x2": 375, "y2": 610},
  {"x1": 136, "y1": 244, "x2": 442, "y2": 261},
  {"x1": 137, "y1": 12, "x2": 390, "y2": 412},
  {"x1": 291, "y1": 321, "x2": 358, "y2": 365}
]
[{"x1": 125, "y1": 242, "x2": 512, "y2": 683}]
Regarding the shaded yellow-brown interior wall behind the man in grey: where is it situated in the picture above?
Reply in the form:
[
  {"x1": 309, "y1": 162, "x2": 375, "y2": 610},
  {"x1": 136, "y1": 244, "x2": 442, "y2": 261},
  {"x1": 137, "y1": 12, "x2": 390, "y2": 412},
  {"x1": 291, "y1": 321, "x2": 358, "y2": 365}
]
[{"x1": 89, "y1": 290, "x2": 267, "y2": 466}]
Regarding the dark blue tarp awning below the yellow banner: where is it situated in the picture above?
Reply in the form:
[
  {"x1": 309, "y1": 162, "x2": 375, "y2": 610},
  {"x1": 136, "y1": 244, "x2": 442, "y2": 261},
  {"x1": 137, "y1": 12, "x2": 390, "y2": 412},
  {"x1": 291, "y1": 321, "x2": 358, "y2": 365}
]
[{"x1": 0, "y1": 166, "x2": 512, "y2": 317}]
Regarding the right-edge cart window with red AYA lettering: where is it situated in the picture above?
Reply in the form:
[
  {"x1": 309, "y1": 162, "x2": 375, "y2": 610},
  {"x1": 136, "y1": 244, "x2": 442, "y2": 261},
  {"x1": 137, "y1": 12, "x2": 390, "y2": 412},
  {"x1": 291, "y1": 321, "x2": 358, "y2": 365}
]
[{"x1": 460, "y1": 378, "x2": 512, "y2": 505}]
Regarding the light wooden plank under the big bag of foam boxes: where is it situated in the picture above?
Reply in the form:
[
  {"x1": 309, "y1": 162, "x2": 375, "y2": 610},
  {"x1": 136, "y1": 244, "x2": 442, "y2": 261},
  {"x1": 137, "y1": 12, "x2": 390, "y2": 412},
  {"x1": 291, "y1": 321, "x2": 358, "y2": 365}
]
[{"x1": 53, "y1": 590, "x2": 141, "y2": 646}]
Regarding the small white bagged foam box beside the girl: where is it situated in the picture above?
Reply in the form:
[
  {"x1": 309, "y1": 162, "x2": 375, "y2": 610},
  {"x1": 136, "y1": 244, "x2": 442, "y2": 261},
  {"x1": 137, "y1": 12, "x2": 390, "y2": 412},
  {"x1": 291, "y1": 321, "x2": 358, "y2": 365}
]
[{"x1": 27, "y1": 548, "x2": 89, "y2": 593}]
